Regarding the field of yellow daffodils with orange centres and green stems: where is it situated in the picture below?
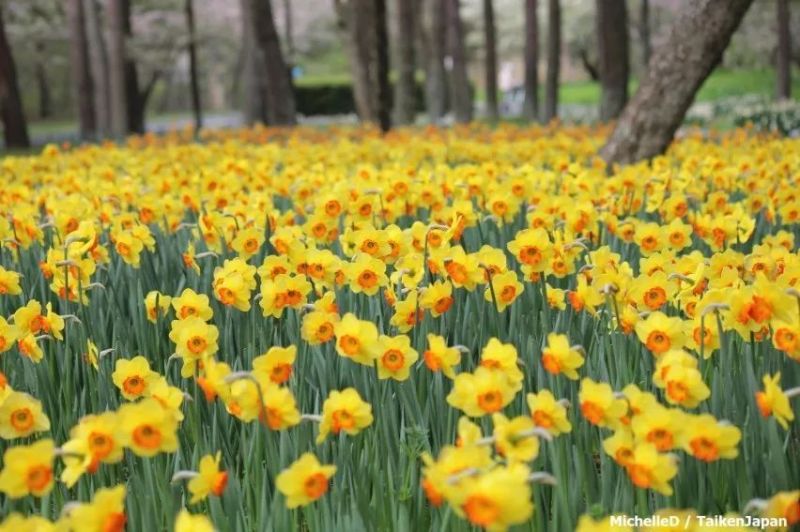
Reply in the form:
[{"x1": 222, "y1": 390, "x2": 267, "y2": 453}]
[{"x1": 0, "y1": 122, "x2": 800, "y2": 532}]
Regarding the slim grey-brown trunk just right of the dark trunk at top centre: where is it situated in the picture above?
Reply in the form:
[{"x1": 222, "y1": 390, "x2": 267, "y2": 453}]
[{"x1": 394, "y1": 0, "x2": 417, "y2": 124}]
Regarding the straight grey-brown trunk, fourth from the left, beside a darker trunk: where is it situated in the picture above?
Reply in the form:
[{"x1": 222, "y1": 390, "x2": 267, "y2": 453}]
[{"x1": 107, "y1": 0, "x2": 128, "y2": 139}]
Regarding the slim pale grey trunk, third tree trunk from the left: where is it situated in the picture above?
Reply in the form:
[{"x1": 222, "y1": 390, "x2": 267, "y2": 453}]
[{"x1": 82, "y1": 0, "x2": 111, "y2": 138}]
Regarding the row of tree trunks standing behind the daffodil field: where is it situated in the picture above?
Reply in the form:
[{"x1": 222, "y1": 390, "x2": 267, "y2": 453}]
[{"x1": 0, "y1": 0, "x2": 791, "y2": 160}]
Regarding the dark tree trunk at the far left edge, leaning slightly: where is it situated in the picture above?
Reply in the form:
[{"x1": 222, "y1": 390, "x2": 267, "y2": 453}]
[{"x1": 0, "y1": 5, "x2": 31, "y2": 148}]
